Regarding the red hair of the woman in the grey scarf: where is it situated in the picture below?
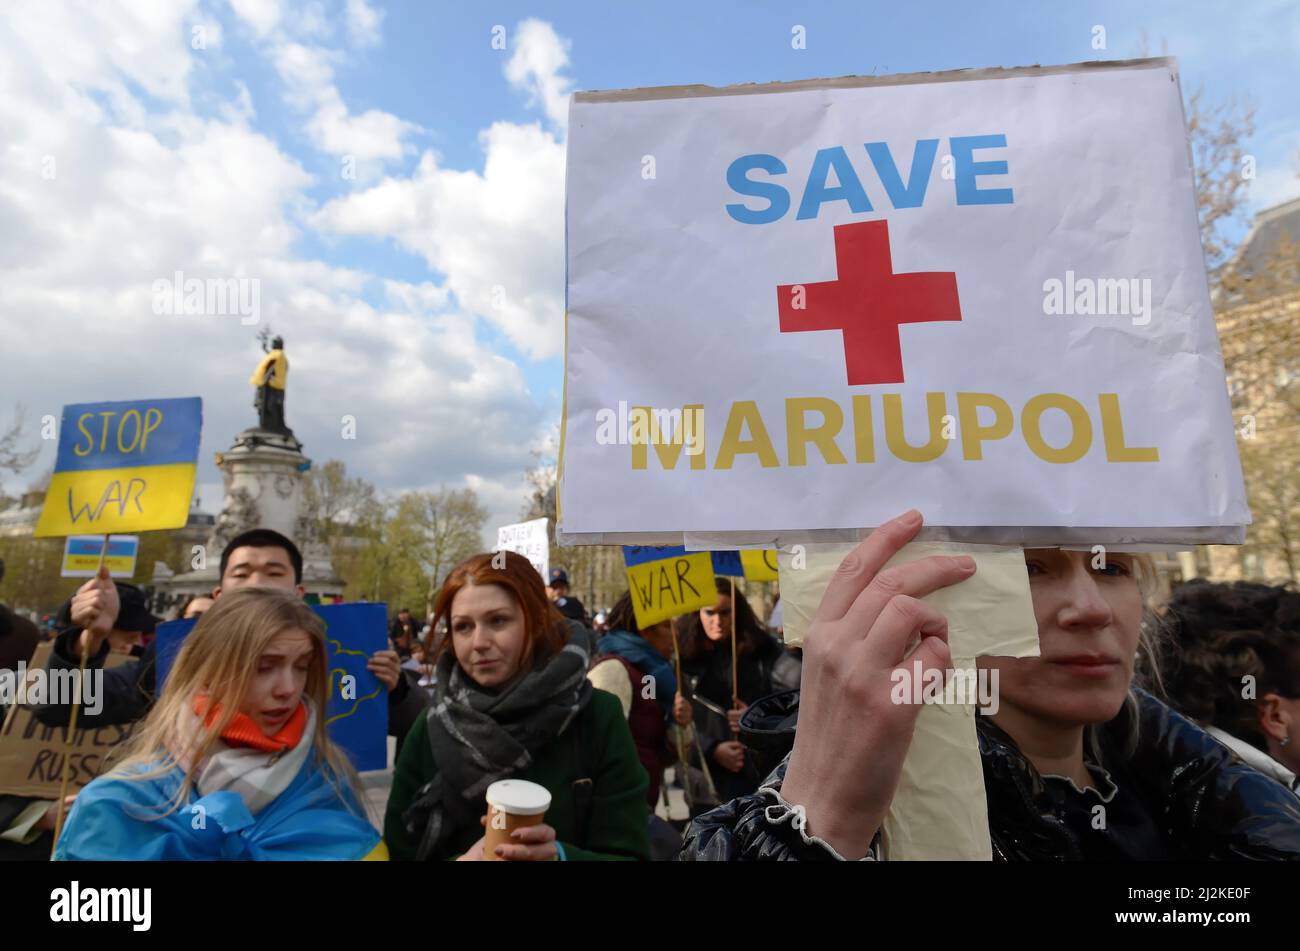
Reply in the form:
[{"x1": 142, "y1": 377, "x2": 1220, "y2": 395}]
[{"x1": 425, "y1": 551, "x2": 568, "y2": 669}]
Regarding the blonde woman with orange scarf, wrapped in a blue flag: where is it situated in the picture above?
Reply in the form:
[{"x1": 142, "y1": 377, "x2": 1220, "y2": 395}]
[{"x1": 55, "y1": 587, "x2": 386, "y2": 860}]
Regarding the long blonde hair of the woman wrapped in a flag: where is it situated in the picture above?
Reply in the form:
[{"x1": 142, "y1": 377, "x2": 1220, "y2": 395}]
[{"x1": 111, "y1": 586, "x2": 360, "y2": 818}]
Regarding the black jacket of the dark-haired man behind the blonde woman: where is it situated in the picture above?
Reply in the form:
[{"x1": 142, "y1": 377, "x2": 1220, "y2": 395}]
[{"x1": 31, "y1": 629, "x2": 429, "y2": 746}]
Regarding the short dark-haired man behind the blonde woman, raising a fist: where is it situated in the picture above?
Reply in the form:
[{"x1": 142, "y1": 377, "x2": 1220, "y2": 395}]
[{"x1": 33, "y1": 529, "x2": 429, "y2": 743}]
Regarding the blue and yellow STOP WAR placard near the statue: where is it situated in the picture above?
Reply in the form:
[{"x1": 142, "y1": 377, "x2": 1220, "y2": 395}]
[{"x1": 34, "y1": 396, "x2": 203, "y2": 538}]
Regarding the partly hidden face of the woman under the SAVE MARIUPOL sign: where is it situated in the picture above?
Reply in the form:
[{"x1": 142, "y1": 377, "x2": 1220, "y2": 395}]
[{"x1": 979, "y1": 548, "x2": 1143, "y2": 726}]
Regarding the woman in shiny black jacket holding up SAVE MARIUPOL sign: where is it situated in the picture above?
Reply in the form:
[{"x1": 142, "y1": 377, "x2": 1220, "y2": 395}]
[{"x1": 679, "y1": 511, "x2": 1300, "y2": 860}]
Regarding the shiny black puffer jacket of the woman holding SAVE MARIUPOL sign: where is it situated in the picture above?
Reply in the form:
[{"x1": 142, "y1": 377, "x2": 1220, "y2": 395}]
[{"x1": 677, "y1": 690, "x2": 1300, "y2": 861}]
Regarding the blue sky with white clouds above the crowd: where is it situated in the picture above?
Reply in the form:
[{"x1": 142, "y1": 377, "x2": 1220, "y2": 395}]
[{"x1": 0, "y1": 0, "x2": 1300, "y2": 537}]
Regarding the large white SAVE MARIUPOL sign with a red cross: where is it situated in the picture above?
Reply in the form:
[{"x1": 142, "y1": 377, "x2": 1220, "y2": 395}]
[{"x1": 559, "y1": 60, "x2": 1249, "y2": 544}]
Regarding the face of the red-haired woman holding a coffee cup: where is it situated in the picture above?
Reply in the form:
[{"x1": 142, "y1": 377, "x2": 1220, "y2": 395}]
[{"x1": 450, "y1": 585, "x2": 528, "y2": 687}]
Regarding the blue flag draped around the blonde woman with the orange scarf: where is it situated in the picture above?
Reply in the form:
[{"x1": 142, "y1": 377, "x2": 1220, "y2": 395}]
[{"x1": 55, "y1": 759, "x2": 382, "y2": 861}]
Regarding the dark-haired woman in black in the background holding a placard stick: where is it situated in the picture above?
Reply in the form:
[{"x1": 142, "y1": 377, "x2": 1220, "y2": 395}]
[{"x1": 681, "y1": 577, "x2": 800, "y2": 816}]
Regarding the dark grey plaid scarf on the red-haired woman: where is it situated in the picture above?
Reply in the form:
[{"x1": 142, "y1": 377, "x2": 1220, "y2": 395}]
[{"x1": 402, "y1": 638, "x2": 592, "y2": 860}]
